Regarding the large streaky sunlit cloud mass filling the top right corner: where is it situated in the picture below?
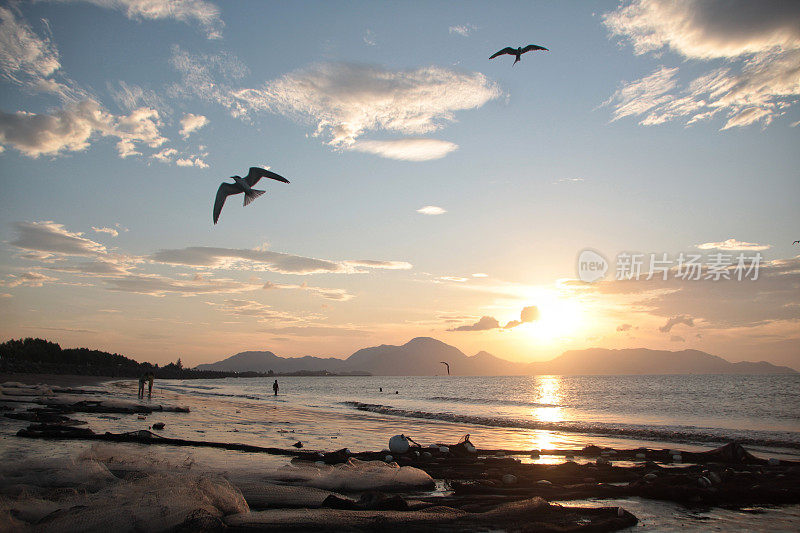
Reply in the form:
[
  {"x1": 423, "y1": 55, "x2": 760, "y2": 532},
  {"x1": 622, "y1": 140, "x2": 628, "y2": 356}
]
[{"x1": 603, "y1": 0, "x2": 800, "y2": 130}]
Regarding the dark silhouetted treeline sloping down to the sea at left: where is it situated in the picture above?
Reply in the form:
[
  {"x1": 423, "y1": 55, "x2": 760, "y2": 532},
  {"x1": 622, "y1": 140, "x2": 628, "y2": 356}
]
[{"x1": 0, "y1": 338, "x2": 271, "y2": 379}]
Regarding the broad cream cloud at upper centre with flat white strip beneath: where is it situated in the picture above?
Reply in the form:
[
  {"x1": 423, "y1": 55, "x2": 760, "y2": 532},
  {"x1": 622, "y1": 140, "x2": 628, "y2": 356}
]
[{"x1": 231, "y1": 63, "x2": 501, "y2": 157}]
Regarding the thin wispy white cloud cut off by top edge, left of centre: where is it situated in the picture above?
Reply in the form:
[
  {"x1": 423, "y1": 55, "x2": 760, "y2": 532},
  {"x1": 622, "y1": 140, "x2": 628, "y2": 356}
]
[{"x1": 58, "y1": 0, "x2": 224, "y2": 39}]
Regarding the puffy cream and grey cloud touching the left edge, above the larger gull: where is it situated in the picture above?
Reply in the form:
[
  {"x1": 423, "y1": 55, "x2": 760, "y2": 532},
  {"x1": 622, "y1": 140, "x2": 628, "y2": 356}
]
[{"x1": 0, "y1": 100, "x2": 167, "y2": 158}]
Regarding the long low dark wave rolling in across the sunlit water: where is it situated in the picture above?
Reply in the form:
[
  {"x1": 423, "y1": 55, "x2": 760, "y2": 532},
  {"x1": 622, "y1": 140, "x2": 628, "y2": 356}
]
[{"x1": 341, "y1": 402, "x2": 800, "y2": 449}]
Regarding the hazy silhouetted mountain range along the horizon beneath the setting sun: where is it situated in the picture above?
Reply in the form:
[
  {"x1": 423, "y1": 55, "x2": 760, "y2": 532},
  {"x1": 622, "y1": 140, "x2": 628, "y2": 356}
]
[{"x1": 196, "y1": 337, "x2": 797, "y2": 376}]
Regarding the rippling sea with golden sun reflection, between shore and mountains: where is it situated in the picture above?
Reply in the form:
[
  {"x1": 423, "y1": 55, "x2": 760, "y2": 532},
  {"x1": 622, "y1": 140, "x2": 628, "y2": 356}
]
[{"x1": 160, "y1": 375, "x2": 800, "y2": 459}]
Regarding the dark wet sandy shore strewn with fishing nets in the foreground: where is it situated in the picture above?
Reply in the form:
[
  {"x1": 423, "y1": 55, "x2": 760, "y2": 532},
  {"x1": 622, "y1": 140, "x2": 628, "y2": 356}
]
[{"x1": 0, "y1": 375, "x2": 800, "y2": 531}]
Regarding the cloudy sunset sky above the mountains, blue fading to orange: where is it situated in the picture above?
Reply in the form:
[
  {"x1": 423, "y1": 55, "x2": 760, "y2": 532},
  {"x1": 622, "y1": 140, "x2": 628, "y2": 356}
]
[{"x1": 0, "y1": 0, "x2": 800, "y2": 369}]
